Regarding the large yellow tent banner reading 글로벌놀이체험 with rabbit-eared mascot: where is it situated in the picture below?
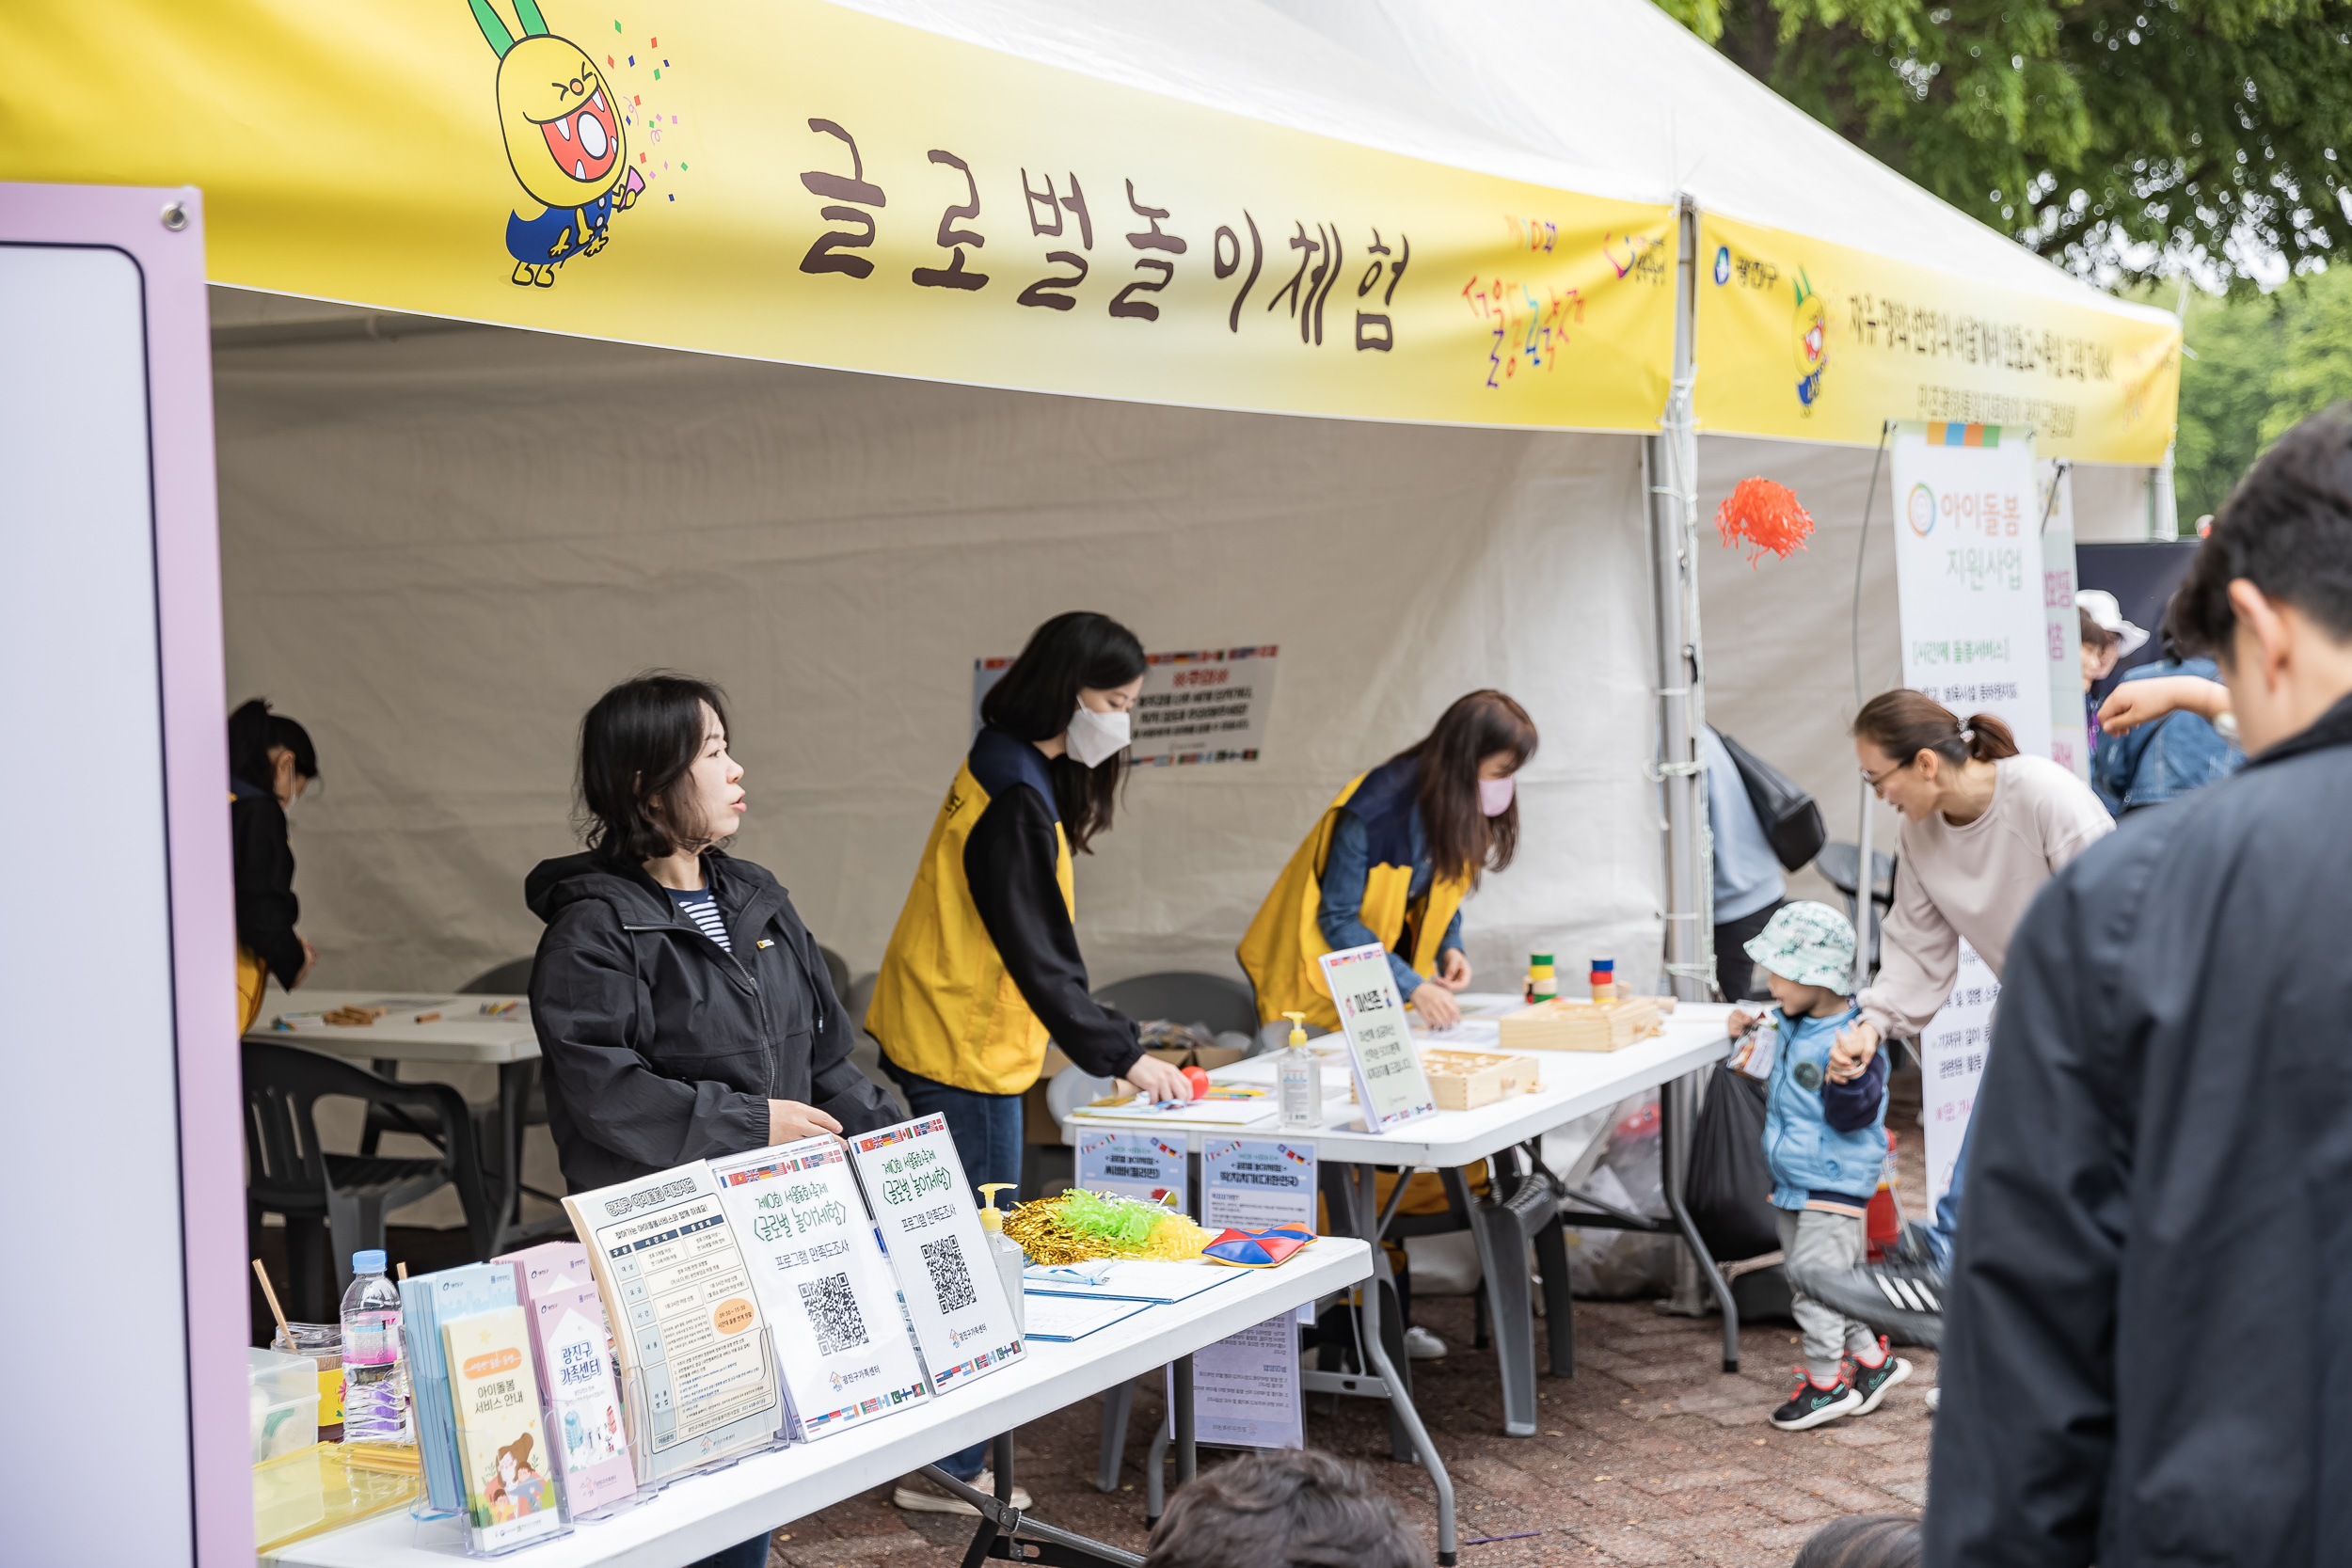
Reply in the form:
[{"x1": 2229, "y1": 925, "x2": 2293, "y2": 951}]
[{"x1": 0, "y1": 0, "x2": 1675, "y2": 430}]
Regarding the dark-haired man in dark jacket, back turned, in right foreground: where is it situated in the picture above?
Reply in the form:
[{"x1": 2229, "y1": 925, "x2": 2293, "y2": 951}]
[{"x1": 1927, "y1": 411, "x2": 2352, "y2": 1568}]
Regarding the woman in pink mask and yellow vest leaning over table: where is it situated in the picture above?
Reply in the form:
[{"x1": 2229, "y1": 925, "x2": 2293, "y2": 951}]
[{"x1": 1240, "y1": 691, "x2": 1536, "y2": 1046}]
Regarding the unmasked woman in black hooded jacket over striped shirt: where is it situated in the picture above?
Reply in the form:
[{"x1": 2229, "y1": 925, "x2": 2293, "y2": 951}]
[{"x1": 525, "y1": 674, "x2": 898, "y2": 1192}]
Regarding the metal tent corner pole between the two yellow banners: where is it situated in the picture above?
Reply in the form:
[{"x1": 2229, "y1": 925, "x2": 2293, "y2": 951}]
[{"x1": 1642, "y1": 195, "x2": 1715, "y2": 1317}]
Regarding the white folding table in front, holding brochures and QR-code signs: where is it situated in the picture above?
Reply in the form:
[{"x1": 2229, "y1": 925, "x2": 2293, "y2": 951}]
[{"x1": 266, "y1": 1237, "x2": 1372, "y2": 1568}]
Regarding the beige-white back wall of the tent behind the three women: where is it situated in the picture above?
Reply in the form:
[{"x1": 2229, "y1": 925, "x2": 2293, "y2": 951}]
[{"x1": 215, "y1": 319, "x2": 1663, "y2": 1010}]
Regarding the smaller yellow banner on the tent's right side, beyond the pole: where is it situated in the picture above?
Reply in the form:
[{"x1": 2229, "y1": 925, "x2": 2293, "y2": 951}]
[{"x1": 1696, "y1": 214, "x2": 2181, "y2": 463}]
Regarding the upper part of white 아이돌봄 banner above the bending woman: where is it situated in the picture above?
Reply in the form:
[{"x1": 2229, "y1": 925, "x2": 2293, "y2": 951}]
[{"x1": 1894, "y1": 423, "x2": 2079, "y2": 757}]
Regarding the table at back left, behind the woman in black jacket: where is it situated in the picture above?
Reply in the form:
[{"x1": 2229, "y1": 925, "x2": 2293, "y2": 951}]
[{"x1": 245, "y1": 980, "x2": 563, "y2": 1251}]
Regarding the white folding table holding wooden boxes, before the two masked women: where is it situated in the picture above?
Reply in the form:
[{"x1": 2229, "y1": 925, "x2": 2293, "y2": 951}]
[{"x1": 1063, "y1": 994, "x2": 1740, "y2": 1561}]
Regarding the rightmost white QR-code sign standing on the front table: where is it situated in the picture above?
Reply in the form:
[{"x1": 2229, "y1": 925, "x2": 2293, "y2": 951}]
[{"x1": 850, "y1": 1115, "x2": 1024, "y2": 1394}]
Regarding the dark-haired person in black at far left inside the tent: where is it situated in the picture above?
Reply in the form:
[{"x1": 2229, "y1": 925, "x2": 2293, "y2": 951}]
[{"x1": 229, "y1": 696, "x2": 318, "y2": 1032}]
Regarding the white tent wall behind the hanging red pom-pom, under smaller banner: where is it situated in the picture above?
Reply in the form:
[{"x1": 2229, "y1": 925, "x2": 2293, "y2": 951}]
[{"x1": 1698, "y1": 435, "x2": 2150, "y2": 905}]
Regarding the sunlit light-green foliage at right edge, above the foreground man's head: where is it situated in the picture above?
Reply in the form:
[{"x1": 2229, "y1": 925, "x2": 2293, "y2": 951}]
[{"x1": 2173, "y1": 268, "x2": 2352, "y2": 531}]
